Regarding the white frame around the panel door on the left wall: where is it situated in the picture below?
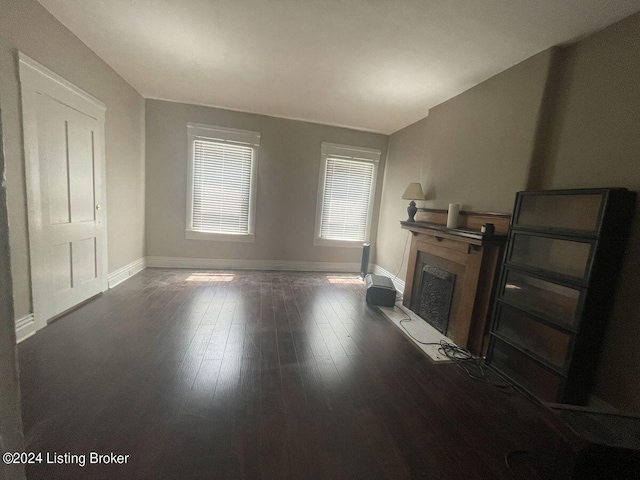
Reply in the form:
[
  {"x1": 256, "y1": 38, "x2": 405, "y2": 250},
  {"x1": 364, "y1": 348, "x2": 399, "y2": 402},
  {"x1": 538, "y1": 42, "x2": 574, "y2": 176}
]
[{"x1": 18, "y1": 52, "x2": 108, "y2": 332}]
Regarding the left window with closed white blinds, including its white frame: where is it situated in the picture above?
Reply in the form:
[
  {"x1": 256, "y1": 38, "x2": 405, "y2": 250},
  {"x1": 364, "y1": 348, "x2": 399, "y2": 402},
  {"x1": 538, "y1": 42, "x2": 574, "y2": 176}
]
[{"x1": 187, "y1": 124, "x2": 260, "y2": 241}]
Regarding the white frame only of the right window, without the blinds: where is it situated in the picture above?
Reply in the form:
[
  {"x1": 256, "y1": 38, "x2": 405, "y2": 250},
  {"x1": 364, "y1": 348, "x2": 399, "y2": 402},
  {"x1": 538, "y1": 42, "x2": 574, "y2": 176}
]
[{"x1": 313, "y1": 142, "x2": 382, "y2": 248}]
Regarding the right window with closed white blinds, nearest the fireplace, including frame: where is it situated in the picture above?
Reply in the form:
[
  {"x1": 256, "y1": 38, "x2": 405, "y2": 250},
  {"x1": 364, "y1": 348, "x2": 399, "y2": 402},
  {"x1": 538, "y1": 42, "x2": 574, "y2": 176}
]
[{"x1": 315, "y1": 143, "x2": 380, "y2": 244}]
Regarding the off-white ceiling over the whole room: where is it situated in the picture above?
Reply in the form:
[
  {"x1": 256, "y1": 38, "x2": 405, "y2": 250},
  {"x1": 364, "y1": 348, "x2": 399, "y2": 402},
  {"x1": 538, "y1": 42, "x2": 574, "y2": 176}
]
[{"x1": 39, "y1": 0, "x2": 640, "y2": 133}]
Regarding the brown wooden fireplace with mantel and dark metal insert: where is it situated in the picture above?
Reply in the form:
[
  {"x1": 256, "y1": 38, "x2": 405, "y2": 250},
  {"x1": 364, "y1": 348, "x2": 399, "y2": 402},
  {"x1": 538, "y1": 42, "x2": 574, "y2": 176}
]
[{"x1": 400, "y1": 209, "x2": 509, "y2": 355}]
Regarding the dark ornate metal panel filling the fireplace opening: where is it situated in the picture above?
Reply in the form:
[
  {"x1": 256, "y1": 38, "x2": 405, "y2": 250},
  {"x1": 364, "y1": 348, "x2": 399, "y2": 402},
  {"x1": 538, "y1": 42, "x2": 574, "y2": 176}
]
[{"x1": 416, "y1": 265, "x2": 456, "y2": 334}]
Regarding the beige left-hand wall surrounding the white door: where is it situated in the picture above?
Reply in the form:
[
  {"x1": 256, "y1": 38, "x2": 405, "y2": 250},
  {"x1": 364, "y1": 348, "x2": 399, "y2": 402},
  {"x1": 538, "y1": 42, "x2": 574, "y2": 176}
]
[{"x1": 0, "y1": 0, "x2": 145, "y2": 318}]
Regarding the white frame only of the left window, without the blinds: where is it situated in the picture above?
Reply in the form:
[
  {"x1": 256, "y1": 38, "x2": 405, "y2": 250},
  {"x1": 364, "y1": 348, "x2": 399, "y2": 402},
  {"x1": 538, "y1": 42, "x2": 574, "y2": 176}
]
[{"x1": 185, "y1": 122, "x2": 260, "y2": 243}]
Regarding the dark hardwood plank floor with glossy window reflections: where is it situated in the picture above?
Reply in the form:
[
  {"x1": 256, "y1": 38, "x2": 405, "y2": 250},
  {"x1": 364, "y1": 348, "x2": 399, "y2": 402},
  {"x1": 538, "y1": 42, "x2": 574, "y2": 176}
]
[{"x1": 18, "y1": 269, "x2": 567, "y2": 480}]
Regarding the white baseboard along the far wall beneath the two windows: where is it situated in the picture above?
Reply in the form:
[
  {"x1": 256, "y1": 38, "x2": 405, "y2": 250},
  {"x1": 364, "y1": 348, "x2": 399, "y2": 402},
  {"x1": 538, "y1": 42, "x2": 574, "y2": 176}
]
[{"x1": 147, "y1": 256, "x2": 360, "y2": 273}]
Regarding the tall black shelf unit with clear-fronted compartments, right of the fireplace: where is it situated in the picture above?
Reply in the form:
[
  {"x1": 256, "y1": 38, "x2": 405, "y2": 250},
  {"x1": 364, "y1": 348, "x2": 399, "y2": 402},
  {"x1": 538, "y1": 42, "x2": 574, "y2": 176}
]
[{"x1": 486, "y1": 188, "x2": 636, "y2": 405}]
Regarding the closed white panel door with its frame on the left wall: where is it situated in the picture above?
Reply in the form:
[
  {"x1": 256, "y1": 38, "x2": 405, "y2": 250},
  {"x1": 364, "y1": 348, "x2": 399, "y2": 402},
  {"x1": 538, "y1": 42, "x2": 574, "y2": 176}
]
[{"x1": 20, "y1": 56, "x2": 106, "y2": 328}]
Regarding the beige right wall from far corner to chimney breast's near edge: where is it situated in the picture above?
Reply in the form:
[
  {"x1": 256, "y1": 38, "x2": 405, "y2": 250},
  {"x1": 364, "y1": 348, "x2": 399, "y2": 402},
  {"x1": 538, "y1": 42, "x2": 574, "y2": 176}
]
[{"x1": 375, "y1": 50, "x2": 552, "y2": 280}]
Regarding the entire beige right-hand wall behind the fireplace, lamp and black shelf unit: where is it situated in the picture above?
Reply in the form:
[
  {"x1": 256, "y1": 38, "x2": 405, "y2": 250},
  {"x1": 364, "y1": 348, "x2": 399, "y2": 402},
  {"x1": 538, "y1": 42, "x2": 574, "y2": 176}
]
[{"x1": 376, "y1": 14, "x2": 640, "y2": 412}]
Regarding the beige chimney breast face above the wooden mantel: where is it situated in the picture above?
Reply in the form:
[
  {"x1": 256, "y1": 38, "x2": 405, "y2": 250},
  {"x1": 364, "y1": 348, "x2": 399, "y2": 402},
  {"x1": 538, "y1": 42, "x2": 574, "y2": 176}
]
[{"x1": 422, "y1": 50, "x2": 552, "y2": 212}]
